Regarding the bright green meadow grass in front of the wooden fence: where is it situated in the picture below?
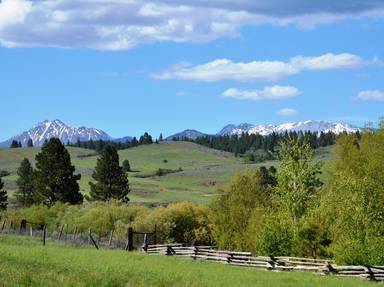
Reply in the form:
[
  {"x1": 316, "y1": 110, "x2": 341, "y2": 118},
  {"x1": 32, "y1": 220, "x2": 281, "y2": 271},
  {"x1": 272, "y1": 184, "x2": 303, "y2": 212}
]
[{"x1": 0, "y1": 235, "x2": 374, "y2": 287}]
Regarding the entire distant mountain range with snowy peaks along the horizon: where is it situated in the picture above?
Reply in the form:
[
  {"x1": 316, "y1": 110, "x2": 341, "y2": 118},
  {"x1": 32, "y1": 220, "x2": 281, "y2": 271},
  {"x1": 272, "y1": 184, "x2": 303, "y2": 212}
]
[{"x1": 0, "y1": 120, "x2": 360, "y2": 147}]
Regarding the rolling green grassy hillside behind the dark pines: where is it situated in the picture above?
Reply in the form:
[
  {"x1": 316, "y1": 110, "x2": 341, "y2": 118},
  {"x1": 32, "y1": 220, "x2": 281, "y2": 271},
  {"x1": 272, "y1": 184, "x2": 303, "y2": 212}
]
[{"x1": 0, "y1": 142, "x2": 280, "y2": 205}]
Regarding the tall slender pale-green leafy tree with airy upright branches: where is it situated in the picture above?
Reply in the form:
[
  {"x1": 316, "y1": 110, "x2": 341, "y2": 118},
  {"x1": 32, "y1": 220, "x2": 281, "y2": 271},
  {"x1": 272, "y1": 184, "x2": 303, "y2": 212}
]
[{"x1": 275, "y1": 138, "x2": 322, "y2": 225}]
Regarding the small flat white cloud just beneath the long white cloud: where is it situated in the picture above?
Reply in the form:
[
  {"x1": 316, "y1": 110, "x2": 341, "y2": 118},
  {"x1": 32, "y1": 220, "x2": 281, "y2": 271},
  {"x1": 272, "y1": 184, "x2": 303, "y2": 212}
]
[{"x1": 222, "y1": 86, "x2": 300, "y2": 101}]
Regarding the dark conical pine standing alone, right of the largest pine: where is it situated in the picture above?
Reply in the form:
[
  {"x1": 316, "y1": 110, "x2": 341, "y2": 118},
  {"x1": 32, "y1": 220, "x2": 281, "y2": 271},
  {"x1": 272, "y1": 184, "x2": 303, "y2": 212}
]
[{"x1": 87, "y1": 145, "x2": 130, "y2": 202}]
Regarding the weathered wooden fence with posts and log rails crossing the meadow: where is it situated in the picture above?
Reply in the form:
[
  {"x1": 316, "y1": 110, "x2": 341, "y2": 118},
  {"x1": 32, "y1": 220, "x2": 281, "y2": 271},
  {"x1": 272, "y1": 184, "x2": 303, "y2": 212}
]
[{"x1": 0, "y1": 221, "x2": 384, "y2": 282}]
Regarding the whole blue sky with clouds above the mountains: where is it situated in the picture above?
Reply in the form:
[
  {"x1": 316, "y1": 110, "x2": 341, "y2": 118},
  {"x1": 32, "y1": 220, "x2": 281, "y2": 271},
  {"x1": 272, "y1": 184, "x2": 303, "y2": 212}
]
[{"x1": 0, "y1": 0, "x2": 384, "y2": 140}]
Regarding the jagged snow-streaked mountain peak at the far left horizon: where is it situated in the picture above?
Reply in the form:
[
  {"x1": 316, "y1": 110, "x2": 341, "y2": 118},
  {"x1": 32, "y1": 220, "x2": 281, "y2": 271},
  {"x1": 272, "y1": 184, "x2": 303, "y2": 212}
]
[{"x1": 0, "y1": 120, "x2": 112, "y2": 147}]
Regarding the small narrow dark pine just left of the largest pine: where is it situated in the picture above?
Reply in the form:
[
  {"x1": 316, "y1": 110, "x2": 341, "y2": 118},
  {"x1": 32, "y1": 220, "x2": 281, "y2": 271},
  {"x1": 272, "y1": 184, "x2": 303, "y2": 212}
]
[{"x1": 15, "y1": 158, "x2": 34, "y2": 206}]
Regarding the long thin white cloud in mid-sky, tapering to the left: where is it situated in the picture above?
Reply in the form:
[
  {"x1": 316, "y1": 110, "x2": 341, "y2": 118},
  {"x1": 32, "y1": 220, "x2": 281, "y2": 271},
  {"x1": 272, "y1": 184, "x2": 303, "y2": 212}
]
[{"x1": 153, "y1": 53, "x2": 369, "y2": 82}]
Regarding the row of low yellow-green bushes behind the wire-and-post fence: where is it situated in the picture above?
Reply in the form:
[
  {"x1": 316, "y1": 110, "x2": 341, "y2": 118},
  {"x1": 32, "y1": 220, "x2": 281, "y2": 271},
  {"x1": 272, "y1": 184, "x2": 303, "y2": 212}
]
[{"x1": 5, "y1": 201, "x2": 211, "y2": 244}]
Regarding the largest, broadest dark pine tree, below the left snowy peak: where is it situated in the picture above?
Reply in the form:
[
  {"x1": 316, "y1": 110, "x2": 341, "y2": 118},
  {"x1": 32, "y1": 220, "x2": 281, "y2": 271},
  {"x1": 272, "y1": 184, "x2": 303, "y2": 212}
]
[{"x1": 35, "y1": 138, "x2": 83, "y2": 205}]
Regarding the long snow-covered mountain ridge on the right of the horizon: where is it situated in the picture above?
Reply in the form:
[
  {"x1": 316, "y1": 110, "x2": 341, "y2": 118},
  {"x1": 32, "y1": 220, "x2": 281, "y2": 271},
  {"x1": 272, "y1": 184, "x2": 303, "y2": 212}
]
[{"x1": 218, "y1": 120, "x2": 360, "y2": 136}]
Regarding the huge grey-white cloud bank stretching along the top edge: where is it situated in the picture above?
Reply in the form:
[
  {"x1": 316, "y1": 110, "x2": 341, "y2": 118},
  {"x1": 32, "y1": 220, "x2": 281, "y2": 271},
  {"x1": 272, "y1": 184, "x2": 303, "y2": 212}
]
[{"x1": 0, "y1": 0, "x2": 384, "y2": 50}]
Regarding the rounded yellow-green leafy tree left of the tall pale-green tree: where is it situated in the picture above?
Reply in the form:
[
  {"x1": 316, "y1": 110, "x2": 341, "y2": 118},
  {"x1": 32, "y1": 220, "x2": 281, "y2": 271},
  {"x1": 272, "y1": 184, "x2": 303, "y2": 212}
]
[{"x1": 211, "y1": 170, "x2": 272, "y2": 251}]
